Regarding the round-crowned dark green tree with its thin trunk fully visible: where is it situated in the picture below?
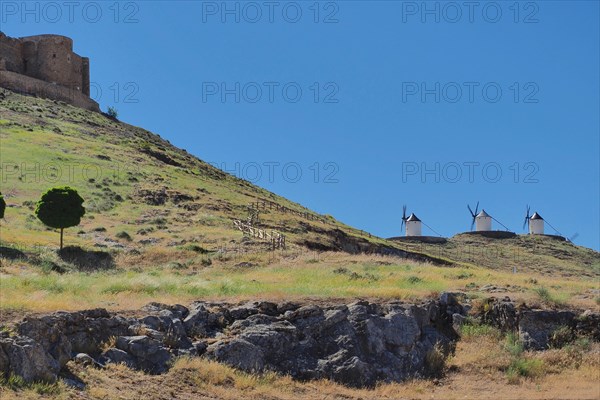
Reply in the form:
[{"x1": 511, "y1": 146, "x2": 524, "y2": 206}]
[{"x1": 35, "y1": 186, "x2": 85, "y2": 250}]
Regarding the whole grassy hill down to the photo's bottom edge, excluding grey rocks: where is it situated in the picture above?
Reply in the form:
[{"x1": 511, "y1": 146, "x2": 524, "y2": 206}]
[{"x1": 0, "y1": 90, "x2": 600, "y2": 399}]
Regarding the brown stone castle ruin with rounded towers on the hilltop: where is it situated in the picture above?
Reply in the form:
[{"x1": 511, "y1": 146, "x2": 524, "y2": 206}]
[{"x1": 0, "y1": 32, "x2": 100, "y2": 112}]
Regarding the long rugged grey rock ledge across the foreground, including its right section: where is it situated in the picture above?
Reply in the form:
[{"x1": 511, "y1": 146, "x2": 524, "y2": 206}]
[{"x1": 0, "y1": 293, "x2": 600, "y2": 387}]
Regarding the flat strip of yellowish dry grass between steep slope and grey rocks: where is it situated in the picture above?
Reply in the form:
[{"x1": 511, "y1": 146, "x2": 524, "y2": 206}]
[{"x1": 0, "y1": 248, "x2": 598, "y2": 311}]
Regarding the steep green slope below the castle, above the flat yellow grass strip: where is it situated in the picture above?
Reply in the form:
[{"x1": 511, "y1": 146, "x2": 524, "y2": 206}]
[{"x1": 0, "y1": 91, "x2": 394, "y2": 255}]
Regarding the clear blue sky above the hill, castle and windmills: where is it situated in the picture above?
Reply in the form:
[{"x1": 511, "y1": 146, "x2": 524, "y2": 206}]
[{"x1": 0, "y1": 1, "x2": 600, "y2": 249}]
